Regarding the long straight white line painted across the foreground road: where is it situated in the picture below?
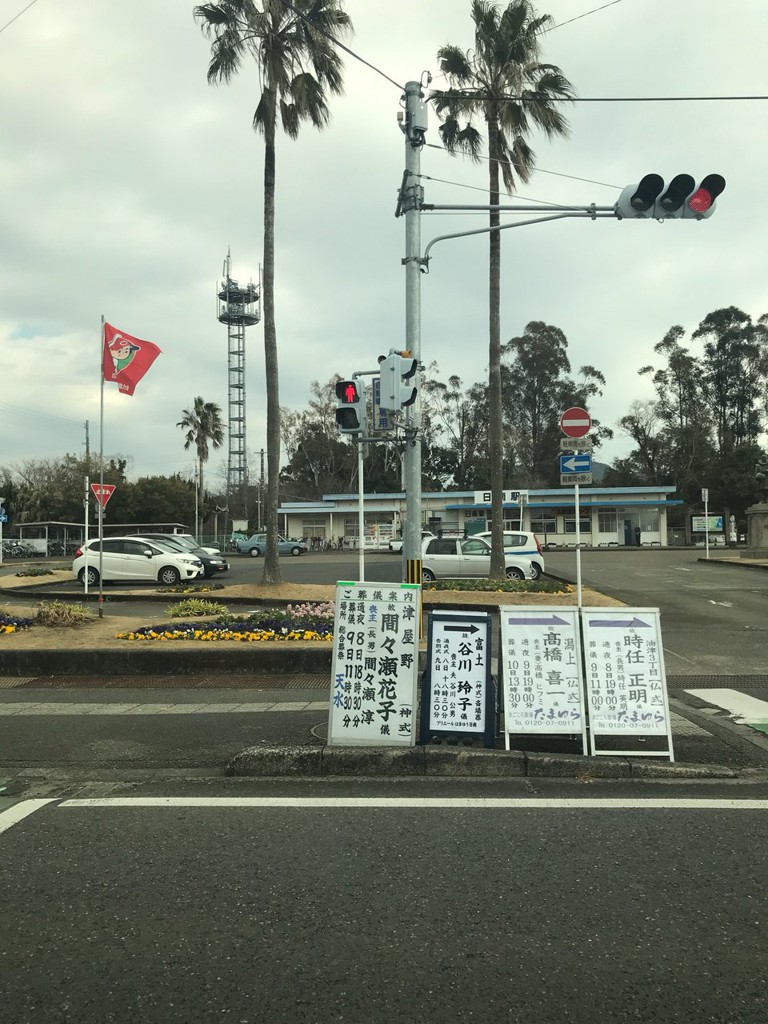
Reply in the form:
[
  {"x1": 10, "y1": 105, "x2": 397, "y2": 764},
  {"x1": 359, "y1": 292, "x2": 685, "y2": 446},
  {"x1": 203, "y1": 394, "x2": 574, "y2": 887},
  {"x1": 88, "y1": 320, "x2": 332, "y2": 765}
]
[{"x1": 58, "y1": 797, "x2": 768, "y2": 811}]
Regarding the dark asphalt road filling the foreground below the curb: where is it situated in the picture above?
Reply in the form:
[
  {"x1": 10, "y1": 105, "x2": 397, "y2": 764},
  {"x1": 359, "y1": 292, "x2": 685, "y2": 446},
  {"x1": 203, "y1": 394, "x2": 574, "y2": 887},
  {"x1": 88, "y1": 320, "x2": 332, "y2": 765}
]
[{"x1": 0, "y1": 780, "x2": 768, "y2": 1024}]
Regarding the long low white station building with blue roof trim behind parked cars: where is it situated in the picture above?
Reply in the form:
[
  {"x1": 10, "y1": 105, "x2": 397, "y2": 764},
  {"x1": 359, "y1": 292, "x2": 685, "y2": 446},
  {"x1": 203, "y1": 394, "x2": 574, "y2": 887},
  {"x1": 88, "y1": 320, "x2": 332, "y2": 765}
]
[{"x1": 279, "y1": 486, "x2": 683, "y2": 550}]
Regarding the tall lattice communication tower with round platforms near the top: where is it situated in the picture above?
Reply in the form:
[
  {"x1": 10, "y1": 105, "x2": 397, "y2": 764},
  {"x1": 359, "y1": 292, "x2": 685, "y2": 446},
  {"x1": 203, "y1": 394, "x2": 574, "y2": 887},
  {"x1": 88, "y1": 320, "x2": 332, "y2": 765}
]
[{"x1": 218, "y1": 250, "x2": 261, "y2": 519}]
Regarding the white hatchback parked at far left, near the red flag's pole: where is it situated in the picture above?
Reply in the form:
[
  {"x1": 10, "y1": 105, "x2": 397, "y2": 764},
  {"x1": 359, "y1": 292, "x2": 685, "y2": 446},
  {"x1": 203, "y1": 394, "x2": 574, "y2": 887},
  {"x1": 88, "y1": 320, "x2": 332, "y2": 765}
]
[{"x1": 72, "y1": 537, "x2": 203, "y2": 587}]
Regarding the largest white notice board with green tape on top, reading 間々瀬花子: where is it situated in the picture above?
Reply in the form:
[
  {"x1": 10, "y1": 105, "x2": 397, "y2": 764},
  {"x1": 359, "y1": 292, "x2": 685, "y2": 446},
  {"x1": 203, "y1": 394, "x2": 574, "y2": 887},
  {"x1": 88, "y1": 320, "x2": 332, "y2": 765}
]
[{"x1": 328, "y1": 583, "x2": 421, "y2": 746}]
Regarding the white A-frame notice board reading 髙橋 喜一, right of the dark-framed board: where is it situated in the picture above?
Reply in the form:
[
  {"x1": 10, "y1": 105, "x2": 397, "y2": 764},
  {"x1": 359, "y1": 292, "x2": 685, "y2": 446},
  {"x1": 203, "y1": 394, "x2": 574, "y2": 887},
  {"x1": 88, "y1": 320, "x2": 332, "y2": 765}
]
[{"x1": 499, "y1": 605, "x2": 587, "y2": 754}]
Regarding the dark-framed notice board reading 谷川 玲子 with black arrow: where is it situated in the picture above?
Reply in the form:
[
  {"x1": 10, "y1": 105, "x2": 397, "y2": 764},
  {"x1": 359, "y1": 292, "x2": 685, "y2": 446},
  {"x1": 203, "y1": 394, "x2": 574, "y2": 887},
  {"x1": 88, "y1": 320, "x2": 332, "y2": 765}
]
[{"x1": 421, "y1": 610, "x2": 496, "y2": 748}]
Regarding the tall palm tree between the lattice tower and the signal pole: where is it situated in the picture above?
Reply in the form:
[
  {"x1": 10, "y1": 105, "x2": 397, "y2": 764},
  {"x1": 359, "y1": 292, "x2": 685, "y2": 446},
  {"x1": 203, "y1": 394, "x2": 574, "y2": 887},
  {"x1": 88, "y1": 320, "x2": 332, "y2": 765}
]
[{"x1": 195, "y1": 0, "x2": 351, "y2": 583}]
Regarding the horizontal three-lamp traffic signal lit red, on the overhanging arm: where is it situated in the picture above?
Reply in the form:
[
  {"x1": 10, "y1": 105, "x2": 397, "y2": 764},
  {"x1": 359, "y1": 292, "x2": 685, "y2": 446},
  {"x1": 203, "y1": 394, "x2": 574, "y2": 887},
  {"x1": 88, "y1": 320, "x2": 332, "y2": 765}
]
[{"x1": 613, "y1": 174, "x2": 725, "y2": 220}]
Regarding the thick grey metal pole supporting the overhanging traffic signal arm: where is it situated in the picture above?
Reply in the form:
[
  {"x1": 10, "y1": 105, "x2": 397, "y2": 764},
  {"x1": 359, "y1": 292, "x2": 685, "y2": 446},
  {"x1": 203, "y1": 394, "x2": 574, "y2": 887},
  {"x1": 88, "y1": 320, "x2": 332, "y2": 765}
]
[{"x1": 403, "y1": 82, "x2": 427, "y2": 584}]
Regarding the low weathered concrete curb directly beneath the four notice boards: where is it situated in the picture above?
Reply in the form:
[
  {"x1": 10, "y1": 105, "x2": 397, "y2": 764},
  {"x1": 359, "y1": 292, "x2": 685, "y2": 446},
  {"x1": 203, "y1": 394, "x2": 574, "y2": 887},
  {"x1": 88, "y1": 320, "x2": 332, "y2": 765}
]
[{"x1": 224, "y1": 746, "x2": 741, "y2": 781}]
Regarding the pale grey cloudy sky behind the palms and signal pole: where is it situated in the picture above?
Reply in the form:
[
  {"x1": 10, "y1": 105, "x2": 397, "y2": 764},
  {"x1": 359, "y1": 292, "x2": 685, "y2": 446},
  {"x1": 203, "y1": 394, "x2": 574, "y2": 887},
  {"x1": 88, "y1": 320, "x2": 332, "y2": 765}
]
[{"x1": 0, "y1": 0, "x2": 768, "y2": 491}]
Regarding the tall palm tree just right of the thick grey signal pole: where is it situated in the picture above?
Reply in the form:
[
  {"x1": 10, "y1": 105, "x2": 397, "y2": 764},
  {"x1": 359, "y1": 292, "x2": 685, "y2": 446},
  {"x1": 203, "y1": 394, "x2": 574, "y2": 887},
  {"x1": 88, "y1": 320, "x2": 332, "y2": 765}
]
[{"x1": 430, "y1": 0, "x2": 573, "y2": 580}]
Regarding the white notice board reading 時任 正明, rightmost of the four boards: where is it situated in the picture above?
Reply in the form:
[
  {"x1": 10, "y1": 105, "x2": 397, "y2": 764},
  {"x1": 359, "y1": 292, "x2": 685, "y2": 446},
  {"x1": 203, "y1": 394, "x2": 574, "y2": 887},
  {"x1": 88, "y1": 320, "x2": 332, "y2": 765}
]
[{"x1": 582, "y1": 607, "x2": 674, "y2": 761}]
